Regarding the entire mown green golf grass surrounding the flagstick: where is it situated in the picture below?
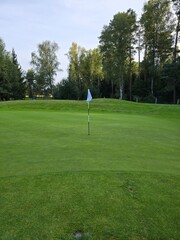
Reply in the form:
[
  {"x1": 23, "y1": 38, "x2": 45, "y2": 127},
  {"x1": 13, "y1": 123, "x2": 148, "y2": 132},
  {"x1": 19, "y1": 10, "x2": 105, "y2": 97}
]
[{"x1": 0, "y1": 99, "x2": 180, "y2": 240}]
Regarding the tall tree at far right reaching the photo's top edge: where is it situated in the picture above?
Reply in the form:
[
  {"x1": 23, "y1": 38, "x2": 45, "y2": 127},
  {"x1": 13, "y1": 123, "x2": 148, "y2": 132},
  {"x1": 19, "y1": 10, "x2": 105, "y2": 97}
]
[{"x1": 141, "y1": 0, "x2": 174, "y2": 96}]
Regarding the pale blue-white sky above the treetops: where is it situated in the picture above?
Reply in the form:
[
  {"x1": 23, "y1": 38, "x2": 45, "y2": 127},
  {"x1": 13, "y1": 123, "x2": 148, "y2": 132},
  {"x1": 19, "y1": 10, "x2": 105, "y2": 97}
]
[{"x1": 0, "y1": 0, "x2": 147, "y2": 81}]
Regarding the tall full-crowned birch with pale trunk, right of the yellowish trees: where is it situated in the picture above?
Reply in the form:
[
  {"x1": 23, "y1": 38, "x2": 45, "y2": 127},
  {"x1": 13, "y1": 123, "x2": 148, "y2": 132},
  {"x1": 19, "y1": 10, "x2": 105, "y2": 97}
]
[{"x1": 99, "y1": 9, "x2": 136, "y2": 99}]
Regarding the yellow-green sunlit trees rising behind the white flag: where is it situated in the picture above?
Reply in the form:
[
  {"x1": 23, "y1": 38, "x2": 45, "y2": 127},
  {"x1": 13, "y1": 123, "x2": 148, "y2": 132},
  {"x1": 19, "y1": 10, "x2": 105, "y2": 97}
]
[{"x1": 66, "y1": 43, "x2": 103, "y2": 99}]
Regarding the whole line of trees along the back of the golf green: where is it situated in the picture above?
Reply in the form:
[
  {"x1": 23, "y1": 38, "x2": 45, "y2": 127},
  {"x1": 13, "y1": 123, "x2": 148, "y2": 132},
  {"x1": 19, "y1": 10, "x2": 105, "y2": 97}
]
[{"x1": 0, "y1": 0, "x2": 180, "y2": 103}]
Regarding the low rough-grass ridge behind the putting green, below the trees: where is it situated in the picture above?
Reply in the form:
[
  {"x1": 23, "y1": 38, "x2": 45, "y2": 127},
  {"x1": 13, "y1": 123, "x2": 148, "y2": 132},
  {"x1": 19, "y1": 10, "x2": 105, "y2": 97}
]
[{"x1": 0, "y1": 98, "x2": 180, "y2": 115}]
